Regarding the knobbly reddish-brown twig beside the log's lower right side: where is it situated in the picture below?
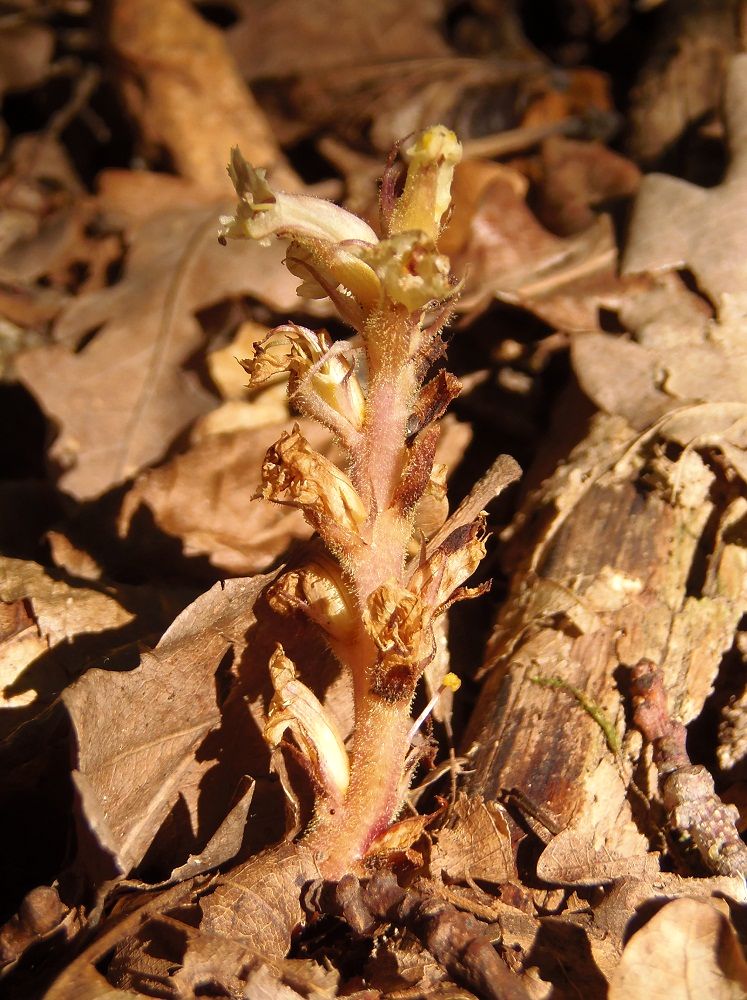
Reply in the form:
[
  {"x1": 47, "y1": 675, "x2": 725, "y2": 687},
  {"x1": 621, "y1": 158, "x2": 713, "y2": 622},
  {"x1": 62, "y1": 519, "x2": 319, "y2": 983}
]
[{"x1": 632, "y1": 659, "x2": 747, "y2": 878}]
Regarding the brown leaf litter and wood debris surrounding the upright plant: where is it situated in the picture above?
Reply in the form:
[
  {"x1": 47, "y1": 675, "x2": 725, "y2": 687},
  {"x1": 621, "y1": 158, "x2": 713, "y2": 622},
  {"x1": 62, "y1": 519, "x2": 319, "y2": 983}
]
[{"x1": 0, "y1": 0, "x2": 747, "y2": 1000}]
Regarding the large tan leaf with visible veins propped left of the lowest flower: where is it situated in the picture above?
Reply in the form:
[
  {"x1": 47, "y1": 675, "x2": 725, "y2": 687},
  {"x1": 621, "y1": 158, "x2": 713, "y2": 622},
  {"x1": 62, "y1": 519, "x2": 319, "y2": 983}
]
[{"x1": 63, "y1": 576, "x2": 273, "y2": 877}]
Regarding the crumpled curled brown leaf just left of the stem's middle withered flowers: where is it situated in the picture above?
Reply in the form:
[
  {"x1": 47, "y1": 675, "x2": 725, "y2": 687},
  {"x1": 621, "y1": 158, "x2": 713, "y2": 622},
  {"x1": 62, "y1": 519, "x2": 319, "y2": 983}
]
[{"x1": 118, "y1": 420, "x2": 331, "y2": 574}]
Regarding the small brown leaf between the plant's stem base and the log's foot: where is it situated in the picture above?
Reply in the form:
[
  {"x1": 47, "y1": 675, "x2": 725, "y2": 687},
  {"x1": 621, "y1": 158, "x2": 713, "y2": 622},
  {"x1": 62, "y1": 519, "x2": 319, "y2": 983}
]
[{"x1": 430, "y1": 793, "x2": 516, "y2": 883}]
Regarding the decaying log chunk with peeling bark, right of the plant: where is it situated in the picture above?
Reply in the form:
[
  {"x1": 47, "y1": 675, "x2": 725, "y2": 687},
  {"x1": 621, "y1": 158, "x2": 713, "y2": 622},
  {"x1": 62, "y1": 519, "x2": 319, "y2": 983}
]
[{"x1": 467, "y1": 404, "x2": 747, "y2": 881}]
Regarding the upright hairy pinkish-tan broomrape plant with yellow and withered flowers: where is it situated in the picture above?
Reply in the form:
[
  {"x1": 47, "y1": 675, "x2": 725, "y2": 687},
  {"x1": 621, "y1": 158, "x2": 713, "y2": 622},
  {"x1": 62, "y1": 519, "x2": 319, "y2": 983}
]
[{"x1": 220, "y1": 126, "x2": 516, "y2": 878}]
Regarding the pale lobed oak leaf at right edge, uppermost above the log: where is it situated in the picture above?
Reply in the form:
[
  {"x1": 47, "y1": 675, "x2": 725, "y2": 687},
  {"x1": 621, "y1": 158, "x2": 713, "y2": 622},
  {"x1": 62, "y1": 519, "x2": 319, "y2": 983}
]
[{"x1": 623, "y1": 54, "x2": 747, "y2": 312}]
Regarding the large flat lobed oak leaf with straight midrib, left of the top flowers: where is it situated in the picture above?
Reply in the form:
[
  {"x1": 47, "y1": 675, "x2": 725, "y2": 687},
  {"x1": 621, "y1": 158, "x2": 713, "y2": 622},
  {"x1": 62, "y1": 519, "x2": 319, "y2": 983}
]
[{"x1": 17, "y1": 196, "x2": 296, "y2": 498}]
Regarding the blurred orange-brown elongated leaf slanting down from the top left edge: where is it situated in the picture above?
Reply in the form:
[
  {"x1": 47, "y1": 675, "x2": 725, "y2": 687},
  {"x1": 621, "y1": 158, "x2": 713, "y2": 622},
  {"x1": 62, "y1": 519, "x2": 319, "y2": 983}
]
[{"x1": 109, "y1": 0, "x2": 299, "y2": 196}]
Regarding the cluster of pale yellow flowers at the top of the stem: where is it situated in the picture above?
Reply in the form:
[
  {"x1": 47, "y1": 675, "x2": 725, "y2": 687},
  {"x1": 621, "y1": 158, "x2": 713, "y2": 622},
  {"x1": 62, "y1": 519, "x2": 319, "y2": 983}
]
[{"x1": 219, "y1": 126, "x2": 461, "y2": 330}]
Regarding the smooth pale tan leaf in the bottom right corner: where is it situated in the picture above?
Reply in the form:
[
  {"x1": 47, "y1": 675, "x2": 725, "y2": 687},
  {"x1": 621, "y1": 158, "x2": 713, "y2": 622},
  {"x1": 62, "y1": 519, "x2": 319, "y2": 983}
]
[{"x1": 609, "y1": 899, "x2": 747, "y2": 1000}]
